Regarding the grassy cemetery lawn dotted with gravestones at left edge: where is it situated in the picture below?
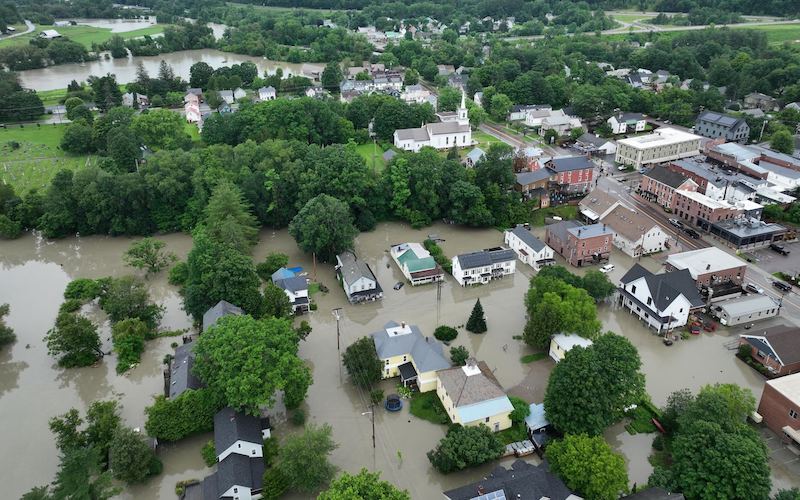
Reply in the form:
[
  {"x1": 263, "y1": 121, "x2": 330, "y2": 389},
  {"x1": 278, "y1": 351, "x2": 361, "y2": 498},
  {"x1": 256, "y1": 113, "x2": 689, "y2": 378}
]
[{"x1": 0, "y1": 125, "x2": 94, "y2": 194}]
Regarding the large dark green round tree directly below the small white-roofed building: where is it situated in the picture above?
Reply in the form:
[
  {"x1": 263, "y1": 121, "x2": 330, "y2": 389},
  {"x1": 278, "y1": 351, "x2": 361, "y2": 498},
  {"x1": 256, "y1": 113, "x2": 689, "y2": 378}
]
[{"x1": 544, "y1": 333, "x2": 645, "y2": 436}]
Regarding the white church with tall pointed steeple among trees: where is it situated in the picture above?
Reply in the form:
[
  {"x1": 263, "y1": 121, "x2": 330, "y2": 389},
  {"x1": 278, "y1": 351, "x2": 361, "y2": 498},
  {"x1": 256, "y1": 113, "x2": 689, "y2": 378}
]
[{"x1": 394, "y1": 92, "x2": 472, "y2": 152}]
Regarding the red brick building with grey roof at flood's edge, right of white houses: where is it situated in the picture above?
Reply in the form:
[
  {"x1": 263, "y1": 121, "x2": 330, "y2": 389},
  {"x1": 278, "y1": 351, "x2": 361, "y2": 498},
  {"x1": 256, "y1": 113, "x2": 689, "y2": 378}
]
[{"x1": 545, "y1": 221, "x2": 614, "y2": 267}]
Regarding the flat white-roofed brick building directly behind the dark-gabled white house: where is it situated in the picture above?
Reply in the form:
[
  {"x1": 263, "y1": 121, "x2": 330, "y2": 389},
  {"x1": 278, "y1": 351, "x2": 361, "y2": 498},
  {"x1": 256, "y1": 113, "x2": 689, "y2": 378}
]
[{"x1": 666, "y1": 247, "x2": 747, "y2": 288}]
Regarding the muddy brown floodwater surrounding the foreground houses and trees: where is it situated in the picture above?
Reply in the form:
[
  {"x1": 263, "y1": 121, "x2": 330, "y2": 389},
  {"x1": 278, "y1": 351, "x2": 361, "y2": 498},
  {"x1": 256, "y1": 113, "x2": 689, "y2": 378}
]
[{"x1": 0, "y1": 223, "x2": 797, "y2": 499}]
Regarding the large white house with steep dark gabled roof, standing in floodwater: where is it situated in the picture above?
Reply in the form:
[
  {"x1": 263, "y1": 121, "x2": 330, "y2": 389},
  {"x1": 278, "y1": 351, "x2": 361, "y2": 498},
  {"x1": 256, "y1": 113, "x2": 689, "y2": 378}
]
[{"x1": 619, "y1": 264, "x2": 704, "y2": 334}]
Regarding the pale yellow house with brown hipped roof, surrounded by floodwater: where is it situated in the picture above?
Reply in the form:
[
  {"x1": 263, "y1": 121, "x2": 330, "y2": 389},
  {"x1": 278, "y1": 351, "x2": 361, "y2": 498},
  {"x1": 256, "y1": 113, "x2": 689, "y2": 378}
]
[{"x1": 436, "y1": 359, "x2": 514, "y2": 432}]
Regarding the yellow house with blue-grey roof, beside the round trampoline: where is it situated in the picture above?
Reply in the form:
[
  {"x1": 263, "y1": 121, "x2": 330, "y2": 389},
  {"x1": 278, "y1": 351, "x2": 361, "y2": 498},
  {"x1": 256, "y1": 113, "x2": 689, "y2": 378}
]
[{"x1": 372, "y1": 321, "x2": 451, "y2": 392}]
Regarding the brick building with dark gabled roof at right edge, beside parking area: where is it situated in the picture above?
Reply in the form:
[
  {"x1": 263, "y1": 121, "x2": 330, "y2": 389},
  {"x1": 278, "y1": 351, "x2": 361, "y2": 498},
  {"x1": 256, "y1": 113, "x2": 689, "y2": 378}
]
[{"x1": 739, "y1": 324, "x2": 800, "y2": 377}]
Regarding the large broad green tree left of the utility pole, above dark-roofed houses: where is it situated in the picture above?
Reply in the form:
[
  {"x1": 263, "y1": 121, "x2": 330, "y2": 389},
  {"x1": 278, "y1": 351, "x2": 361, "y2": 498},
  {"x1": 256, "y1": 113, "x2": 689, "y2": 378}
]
[{"x1": 193, "y1": 316, "x2": 311, "y2": 414}]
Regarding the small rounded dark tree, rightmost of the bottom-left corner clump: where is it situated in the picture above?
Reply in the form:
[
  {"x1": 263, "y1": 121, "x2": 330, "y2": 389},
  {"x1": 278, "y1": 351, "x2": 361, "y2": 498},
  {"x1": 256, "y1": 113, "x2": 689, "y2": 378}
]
[{"x1": 108, "y1": 427, "x2": 160, "y2": 484}]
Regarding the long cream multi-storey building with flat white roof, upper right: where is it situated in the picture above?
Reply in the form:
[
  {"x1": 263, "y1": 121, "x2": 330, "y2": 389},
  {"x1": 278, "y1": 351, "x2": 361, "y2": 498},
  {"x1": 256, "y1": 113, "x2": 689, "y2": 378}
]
[{"x1": 614, "y1": 127, "x2": 700, "y2": 168}]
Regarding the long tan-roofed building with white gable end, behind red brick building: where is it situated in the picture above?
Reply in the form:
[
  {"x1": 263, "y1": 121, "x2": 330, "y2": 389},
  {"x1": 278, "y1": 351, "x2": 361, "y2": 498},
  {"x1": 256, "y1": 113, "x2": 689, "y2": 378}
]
[{"x1": 601, "y1": 205, "x2": 669, "y2": 257}]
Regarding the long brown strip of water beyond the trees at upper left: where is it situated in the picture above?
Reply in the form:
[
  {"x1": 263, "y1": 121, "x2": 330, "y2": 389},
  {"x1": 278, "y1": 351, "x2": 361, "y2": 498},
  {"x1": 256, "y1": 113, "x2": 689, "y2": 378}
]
[{"x1": 17, "y1": 49, "x2": 324, "y2": 90}]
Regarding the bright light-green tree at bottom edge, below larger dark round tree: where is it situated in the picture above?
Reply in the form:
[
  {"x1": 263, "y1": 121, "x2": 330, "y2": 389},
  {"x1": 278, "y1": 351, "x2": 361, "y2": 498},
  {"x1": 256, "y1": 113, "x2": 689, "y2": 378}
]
[{"x1": 546, "y1": 434, "x2": 628, "y2": 500}]
